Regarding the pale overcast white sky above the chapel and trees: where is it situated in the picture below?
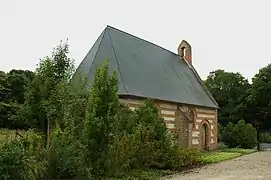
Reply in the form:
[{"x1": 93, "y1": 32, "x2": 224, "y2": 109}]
[{"x1": 0, "y1": 0, "x2": 271, "y2": 79}]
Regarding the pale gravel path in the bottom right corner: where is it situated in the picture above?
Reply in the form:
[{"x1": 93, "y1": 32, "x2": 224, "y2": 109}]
[{"x1": 164, "y1": 151, "x2": 271, "y2": 180}]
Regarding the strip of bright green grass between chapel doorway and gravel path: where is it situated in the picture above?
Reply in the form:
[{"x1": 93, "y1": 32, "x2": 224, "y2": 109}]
[{"x1": 202, "y1": 148, "x2": 255, "y2": 164}]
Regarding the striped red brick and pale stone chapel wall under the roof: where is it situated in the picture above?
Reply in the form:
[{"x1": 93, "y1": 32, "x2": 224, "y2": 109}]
[{"x1": 121, "y1": 98, "x2": 218, "y2": 150}]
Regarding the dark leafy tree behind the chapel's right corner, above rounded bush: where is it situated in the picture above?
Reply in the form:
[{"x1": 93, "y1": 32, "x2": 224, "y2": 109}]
[{"x1": 205, "y1": 69, "x2": 251, "y2": 125}]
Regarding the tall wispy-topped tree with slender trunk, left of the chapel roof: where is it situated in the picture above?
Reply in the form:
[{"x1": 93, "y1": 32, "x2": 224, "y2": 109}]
[{"x1": 21, "y1": 39, "x2": 74, "y2": 146}]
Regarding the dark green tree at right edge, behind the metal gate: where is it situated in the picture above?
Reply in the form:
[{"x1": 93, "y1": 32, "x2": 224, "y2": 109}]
[{"x1": 247, "y1": 64, "x2": 271, "y2": 129}]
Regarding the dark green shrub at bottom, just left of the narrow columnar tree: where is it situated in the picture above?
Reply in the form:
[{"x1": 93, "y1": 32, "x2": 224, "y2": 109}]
[{"x1": 48, "y1": 125, "x2": 84, "y2": 179}]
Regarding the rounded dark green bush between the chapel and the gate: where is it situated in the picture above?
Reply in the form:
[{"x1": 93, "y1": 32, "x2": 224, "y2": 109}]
[{"x1": 222, "y1": 120, "x2": 257, "y2": 149}]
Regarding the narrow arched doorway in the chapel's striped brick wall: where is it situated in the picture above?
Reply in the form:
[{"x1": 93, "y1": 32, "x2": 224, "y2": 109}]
[{"x1": 199, "y1": 119, "x2": 211, "y2": 150}]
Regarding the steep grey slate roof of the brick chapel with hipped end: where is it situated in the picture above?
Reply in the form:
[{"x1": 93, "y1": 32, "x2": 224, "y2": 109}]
[{"x1": 75, "y1": 26, "x2": 218, "y2": 108}]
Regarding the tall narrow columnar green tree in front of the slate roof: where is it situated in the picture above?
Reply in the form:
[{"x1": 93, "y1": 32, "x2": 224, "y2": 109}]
[{"x1": 84, "y1": 62, "x2": 119, "y2": 176}]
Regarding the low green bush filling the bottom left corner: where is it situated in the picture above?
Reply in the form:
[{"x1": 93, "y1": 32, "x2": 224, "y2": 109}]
[{"x1": 0, "y1": 131, "x2": 46, "y2": 180}]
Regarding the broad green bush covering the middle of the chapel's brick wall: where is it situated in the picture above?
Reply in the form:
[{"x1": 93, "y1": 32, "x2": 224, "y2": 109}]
[{"x1": 107, "y1": 100, "x2": 204, "y2": 176}]
